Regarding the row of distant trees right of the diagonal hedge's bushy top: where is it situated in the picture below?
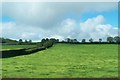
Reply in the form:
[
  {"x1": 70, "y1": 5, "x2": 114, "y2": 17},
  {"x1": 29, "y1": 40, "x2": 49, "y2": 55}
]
[{"x1": 41, "y1": 36, "x2": 120, "y2": 44}]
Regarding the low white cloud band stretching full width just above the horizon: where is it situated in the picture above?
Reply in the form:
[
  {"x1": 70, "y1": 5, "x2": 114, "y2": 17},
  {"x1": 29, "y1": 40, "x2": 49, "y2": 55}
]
[{"x1": 0, "y1": 15, "x2": 118, "y2": 41}]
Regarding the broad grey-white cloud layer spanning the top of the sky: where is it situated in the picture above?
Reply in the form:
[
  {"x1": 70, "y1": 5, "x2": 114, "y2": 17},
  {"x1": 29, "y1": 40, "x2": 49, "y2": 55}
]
[{"x1": 2, "y1": 2, "x2": 118, "y2": 29}]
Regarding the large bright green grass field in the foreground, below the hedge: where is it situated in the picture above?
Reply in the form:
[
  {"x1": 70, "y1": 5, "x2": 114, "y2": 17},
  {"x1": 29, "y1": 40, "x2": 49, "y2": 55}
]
[{"x1": 1, "y1": 44, "x2": 118, "y2": 78}]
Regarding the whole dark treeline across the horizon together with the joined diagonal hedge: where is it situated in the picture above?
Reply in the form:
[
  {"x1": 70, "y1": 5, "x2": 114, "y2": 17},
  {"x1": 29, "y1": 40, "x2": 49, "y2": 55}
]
[{"x1": 0, "y1": 36, "x2": 120, "y2": 58}]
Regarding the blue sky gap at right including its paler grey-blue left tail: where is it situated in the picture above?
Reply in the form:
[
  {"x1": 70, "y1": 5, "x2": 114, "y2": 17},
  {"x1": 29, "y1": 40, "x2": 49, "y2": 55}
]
[{"x1": 65, "y1": 8, "x2": 118, "y2": 27}]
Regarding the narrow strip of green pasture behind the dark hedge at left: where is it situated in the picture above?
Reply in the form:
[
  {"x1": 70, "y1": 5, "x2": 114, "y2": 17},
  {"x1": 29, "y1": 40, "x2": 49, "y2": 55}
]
[{"x1": 2, "y1": 45, "x2": 35, "y2": 50}]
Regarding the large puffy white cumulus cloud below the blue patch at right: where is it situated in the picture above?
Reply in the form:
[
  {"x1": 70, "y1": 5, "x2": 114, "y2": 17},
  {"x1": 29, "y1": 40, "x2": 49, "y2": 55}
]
[{"x1": 80, "y1": 15, "x2": 118, "y2": 40}]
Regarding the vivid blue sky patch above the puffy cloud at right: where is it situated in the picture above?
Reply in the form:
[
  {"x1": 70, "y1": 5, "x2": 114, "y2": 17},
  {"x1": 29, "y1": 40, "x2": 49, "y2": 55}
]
[{"x1": 82, "y1": 9, "x2": 118, "y2": 27}]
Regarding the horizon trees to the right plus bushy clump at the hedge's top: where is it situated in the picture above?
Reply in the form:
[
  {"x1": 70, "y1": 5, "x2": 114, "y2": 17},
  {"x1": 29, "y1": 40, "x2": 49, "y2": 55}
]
[{"x1": 37, "y1": 36, "x2": 120, "y2": 48}]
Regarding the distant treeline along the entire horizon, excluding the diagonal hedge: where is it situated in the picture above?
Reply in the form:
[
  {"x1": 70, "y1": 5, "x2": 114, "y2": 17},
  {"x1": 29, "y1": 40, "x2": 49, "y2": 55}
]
[{"x1": 0, "y1": 36, "x2": 120, "y2": 46}]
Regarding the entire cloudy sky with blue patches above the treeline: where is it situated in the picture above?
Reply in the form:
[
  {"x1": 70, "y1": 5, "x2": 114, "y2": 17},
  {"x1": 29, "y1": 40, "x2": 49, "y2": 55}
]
[{"x1": 0, "y1": 2, "x2": 118, "y2": 41}]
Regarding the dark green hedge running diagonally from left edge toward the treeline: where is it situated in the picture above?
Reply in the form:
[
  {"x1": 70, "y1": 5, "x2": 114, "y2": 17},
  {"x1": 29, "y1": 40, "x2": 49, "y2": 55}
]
[{"x1": 2, "y1": 40, "x2": 54, "y2": 58}]
